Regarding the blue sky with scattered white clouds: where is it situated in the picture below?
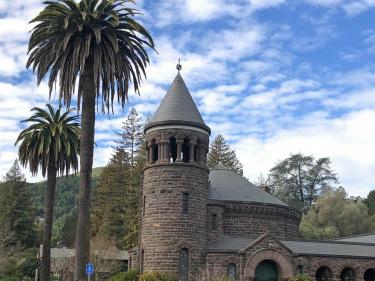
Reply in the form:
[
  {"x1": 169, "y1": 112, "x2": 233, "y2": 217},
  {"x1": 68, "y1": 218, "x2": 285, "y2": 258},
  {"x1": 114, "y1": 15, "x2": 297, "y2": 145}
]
[{"x1": 0, "y1": 0, "x2": 375, "y2": 196}]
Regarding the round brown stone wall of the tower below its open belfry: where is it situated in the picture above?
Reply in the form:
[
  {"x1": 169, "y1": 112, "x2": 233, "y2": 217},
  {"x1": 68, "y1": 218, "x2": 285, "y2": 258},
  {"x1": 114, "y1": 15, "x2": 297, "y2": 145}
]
[{"x1": 141, "y1": 163, "x2": 212, "y2": 274}]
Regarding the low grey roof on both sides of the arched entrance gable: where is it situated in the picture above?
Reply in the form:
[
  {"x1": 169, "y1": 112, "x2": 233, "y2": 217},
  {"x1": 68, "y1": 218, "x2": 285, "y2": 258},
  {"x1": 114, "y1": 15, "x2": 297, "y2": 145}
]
[{"x1": 207, "y1": 237, "x2": 375, "y2": 258}]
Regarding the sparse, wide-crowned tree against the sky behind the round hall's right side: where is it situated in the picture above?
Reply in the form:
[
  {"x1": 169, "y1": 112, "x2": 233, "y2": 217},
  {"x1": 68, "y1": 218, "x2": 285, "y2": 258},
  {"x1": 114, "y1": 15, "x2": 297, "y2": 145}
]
[{"x1": 268, "y1": 153, "x2": 338, "y2": 212}]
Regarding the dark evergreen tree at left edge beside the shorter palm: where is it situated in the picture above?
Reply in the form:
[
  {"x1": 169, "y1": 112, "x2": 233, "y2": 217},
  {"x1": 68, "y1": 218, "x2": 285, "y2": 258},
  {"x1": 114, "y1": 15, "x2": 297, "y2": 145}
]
[{"x1": 0, "y1": 161, "x2": 37, "y2": 248}]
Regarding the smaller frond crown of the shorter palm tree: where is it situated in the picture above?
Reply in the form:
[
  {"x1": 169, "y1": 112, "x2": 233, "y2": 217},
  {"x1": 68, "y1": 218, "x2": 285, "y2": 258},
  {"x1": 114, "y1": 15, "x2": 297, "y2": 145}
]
[{"x1": 16, "y1": 104, "x2": 81, "y2": 177}]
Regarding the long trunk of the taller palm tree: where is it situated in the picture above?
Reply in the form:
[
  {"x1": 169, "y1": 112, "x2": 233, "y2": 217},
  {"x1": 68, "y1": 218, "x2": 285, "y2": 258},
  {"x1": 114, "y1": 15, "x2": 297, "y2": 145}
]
[{"x1": 74, "y1": 60, "x2": 95, "y2": 281}]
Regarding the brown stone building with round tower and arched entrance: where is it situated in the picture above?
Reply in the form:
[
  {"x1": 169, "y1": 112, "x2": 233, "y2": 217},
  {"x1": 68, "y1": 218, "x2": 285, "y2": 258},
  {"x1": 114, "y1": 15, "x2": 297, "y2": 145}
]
[{"x1": 130, "y1": 68, "x2": 375, "y2": 281}]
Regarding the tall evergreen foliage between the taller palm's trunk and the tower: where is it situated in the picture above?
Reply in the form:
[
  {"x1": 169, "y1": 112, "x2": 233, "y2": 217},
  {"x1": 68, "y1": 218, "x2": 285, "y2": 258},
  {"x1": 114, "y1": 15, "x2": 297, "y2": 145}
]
[{"x1": 91, "y1": 109, "x2": 145, "y2": 249}]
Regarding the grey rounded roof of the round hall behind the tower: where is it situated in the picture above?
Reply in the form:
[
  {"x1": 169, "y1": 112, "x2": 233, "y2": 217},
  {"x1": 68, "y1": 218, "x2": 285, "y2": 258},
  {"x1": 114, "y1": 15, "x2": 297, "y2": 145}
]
[{"x1": 208, "y1": 164, "x2": 287, "y2": 206}]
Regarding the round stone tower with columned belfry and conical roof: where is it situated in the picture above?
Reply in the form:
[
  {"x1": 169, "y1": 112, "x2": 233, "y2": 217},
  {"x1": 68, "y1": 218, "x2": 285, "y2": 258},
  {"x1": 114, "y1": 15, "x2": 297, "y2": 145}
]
[{"x1": 140, "y1": 70, "x2": 210, "y2": 281}]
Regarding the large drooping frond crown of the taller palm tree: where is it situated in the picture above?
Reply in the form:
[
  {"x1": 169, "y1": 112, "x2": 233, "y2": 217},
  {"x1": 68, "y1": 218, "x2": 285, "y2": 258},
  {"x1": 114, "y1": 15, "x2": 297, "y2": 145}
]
[{"x1": 27, "y1": 0, "x2": 154, "y2": 111}]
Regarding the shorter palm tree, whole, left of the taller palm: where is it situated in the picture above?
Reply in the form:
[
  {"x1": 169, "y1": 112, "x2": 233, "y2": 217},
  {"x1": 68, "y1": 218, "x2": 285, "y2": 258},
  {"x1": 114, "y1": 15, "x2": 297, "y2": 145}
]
[{"x1": 16, "y1": 104, "x2": 81, "y2": 281}]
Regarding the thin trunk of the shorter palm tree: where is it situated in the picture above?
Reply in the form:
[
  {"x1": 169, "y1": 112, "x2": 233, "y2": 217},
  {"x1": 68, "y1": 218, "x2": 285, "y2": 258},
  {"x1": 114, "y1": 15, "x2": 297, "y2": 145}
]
[{"x1": 40, "y1": 167, "x2": 57, "y2": 281}]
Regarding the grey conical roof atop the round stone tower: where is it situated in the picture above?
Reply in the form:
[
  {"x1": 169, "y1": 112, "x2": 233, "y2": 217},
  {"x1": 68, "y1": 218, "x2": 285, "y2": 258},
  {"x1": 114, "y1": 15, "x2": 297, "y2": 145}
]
[{"x1": 146, "y1": 72, "x2": 210, "y2": 133}]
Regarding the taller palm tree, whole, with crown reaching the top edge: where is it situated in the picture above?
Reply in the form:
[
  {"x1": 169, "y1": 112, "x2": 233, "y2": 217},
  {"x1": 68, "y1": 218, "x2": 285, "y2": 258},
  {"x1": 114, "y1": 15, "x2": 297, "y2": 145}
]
[{"x1": 27, "y1": 0, "x2": 154, "y2": 281}]
